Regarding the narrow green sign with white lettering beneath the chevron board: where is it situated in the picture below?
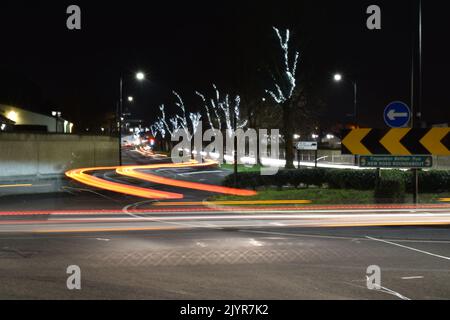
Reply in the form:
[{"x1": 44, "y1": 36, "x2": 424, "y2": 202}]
[{"x1": 359, "y1": 156, "x2": 433, "y2": 168}]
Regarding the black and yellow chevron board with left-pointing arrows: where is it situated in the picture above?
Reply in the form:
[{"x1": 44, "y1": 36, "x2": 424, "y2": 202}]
[{"x1": 342, "y1": 128, "x2": 450, "y2": 156}]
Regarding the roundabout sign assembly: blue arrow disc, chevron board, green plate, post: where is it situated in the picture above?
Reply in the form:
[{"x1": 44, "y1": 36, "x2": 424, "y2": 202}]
[{"x1": 342, "y1": 129, "x2": 450, "y2": 204}]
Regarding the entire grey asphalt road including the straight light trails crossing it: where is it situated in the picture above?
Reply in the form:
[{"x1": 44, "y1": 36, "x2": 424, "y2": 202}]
[{"x1": 0, "y1": 148, "x2": 450, "y2": 300}]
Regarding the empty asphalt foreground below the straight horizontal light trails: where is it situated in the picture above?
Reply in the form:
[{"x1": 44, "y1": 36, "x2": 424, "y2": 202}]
[{"x1": 0, "y1": 227, "x2": 450, "y2": 299}]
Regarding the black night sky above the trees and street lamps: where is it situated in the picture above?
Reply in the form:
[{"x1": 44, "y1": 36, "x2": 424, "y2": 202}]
[{"x1": 0, "y1": 0, "x2": 450, "y2": 131}]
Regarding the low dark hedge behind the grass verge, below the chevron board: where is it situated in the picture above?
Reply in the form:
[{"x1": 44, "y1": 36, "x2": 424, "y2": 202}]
[{"x1": 223, "y1": 168, "x2": 450, "y2": 193}]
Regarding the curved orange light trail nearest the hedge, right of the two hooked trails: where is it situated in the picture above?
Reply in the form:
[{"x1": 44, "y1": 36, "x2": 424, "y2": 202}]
[{"x1": 116, "y1": 161, "x2": 256, "y2": 196}]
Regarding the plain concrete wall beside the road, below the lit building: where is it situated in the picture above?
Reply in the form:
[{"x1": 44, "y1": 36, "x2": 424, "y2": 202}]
[{"x1": 0, "y1": 133, "x2": 119, "y2": 179}]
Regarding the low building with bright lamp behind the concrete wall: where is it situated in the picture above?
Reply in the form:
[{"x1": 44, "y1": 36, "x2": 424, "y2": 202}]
[{"x1": 0, "y1": 104, "x2": 73, "y2": 133}]
